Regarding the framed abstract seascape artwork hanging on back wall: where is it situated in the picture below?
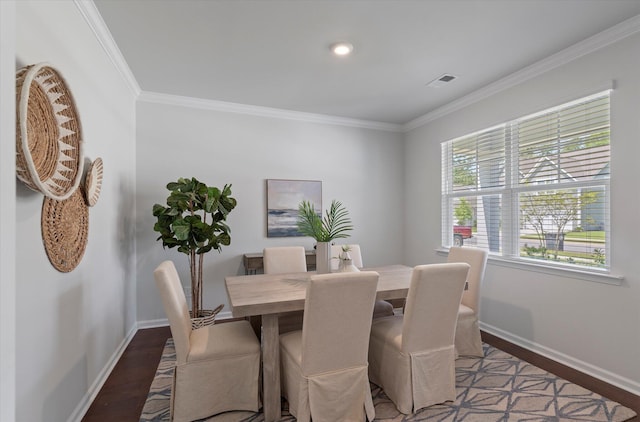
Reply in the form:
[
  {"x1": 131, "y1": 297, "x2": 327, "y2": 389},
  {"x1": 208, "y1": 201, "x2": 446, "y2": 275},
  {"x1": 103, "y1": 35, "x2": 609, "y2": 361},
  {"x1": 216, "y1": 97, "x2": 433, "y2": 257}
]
[{"x1": 267, "y1": 179, "x2": 322, "y2": 237}]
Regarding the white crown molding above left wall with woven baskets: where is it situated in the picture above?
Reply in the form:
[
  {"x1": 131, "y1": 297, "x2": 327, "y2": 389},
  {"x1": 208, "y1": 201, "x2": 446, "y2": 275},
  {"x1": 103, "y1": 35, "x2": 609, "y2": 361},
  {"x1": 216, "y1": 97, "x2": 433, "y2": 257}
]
[{"x1": 74, "y1": 0, "x2": 141, "y2": 97}]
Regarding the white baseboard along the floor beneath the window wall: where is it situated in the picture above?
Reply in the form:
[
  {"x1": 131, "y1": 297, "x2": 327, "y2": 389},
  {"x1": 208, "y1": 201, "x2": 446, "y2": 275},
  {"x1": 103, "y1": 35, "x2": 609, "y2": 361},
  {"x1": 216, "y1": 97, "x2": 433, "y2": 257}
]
[{"x1": 480, "y1": 322, "x2": 640, "y2": 396}]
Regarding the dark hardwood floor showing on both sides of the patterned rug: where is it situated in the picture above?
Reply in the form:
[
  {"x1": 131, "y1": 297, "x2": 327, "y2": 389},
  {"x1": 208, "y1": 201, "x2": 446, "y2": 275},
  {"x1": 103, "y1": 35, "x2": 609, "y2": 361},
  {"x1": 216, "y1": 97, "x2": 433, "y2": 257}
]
[{"x1": 82, "y1": 327, "x2": 640, "y2": 422}]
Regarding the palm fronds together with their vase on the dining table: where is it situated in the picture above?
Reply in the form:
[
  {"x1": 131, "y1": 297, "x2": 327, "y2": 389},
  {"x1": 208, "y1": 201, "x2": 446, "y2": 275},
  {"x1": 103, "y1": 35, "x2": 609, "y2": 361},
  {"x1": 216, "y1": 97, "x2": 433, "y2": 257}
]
[{"x1": 297, "y1": 199, "x2": 353, "y2": 274}]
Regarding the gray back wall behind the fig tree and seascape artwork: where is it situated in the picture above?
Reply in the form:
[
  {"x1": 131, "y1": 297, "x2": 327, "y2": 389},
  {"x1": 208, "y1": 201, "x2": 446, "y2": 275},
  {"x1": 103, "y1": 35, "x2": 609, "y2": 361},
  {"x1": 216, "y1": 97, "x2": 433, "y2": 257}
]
[{"x1": 136, "y1": 101, "x2": 404, "y2": 322}]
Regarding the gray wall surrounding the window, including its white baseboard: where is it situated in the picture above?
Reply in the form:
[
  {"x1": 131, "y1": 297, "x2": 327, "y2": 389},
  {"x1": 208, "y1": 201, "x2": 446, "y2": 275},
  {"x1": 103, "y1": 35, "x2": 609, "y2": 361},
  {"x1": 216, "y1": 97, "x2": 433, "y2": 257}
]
[{"x1": 404, "y1": 34, "x2": 640, "y2": 393}]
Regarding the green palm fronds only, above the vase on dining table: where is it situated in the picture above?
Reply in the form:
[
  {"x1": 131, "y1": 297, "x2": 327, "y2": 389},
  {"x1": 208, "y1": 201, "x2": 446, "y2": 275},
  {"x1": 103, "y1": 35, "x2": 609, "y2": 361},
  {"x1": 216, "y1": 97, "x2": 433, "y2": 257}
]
[{"x1": 297, "y1": 199, "x2": 353, "y2": 242}]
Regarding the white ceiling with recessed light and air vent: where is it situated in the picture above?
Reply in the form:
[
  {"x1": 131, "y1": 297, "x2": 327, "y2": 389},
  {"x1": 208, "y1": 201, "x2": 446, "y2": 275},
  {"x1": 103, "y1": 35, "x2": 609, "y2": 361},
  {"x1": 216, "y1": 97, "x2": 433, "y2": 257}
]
[{"x1": 94, "y1": 0, "x2": 640, "y2": 124}]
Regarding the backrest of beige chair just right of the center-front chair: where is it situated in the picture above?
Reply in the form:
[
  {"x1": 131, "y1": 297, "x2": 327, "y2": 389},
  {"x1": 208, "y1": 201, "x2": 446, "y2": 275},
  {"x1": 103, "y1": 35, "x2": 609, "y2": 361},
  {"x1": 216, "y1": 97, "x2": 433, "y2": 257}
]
[{"x1": 401, "y1": 263, "x2": 469, "y2": 354}]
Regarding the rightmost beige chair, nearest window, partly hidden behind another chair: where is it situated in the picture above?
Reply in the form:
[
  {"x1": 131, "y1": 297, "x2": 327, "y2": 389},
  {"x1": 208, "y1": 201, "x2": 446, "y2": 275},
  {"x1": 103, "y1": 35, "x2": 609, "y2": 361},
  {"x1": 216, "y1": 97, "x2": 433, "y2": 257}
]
[{"x1": 447, "y1": 246, "x2": 487, "y2": 357}]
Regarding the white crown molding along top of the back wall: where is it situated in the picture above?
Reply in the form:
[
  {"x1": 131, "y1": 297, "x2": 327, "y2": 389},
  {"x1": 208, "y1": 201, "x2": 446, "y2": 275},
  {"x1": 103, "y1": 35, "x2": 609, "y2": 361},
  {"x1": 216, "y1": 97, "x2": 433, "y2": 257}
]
[{"x1": 138, "y1": 91, "x2": 402, "y2": 132}]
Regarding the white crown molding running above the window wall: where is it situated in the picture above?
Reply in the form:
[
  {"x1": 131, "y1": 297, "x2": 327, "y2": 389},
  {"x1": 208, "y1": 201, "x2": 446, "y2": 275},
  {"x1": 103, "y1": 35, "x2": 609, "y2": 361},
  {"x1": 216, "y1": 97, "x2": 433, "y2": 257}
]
[{"x1": 402, "y1": 15, "x2": 640, "y2": 132}]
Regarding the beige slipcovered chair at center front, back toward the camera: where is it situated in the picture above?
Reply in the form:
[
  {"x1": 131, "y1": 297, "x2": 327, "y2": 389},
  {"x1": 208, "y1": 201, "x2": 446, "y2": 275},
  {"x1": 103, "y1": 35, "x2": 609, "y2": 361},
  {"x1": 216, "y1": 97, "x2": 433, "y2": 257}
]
[{"x1": 280, "y1": 271, "x2": 378, "y2": 422}]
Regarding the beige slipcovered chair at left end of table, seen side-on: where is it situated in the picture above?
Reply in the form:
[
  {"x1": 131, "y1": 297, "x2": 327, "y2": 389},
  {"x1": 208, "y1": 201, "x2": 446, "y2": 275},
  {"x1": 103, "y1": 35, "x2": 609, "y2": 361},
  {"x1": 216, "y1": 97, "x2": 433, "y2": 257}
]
[{"x1": 153, "y1": 261, "x2": 260, "y2": 421}]
